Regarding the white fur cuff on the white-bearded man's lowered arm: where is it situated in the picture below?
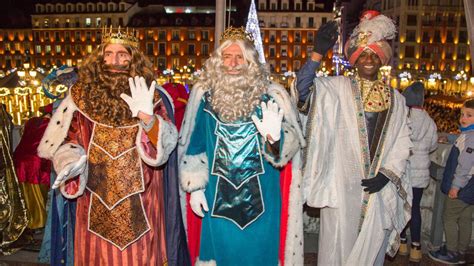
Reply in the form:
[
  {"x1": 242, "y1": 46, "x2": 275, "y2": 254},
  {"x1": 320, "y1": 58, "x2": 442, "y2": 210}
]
[{"x1": 179, "y1": 153, "x2": 209, "y2": 192}]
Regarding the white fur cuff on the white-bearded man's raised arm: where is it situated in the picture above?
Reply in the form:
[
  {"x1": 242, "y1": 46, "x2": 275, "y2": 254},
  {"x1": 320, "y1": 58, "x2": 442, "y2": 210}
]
[{"x1": 262, "y1": 122, "x2": 300, "y2": 168}]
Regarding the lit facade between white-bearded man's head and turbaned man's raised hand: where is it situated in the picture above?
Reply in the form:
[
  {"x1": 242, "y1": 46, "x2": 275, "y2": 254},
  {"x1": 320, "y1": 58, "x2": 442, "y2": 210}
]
[{"x1": 255, "y1": 0, "x2": 334, "y2": 73}]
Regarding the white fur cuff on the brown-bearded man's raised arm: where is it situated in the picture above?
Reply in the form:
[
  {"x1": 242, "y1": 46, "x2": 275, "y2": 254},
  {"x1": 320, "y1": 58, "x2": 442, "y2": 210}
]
[{"x1": 136, "y1": 115, "x2": 178, "y2": 166}]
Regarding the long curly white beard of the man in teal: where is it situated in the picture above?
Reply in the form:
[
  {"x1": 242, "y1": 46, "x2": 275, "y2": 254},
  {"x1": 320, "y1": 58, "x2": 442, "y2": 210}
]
[{"x1": 210, "y1": 68, "x2": 265, "y2": 122}]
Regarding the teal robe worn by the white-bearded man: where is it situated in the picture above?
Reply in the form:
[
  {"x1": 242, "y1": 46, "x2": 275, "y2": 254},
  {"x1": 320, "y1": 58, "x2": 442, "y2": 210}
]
[{"x1": 186, "y1": 96, "x2": 284, "y2": 266}]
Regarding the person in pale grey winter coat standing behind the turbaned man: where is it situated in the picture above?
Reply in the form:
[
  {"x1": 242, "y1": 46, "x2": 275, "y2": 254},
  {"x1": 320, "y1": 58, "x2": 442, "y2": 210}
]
[{"x1": 398, "y1": 82, "x2": 438, "y2": 262}]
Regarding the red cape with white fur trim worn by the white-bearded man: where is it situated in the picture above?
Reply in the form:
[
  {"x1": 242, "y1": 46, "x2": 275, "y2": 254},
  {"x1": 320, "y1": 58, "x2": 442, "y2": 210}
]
[{"x1": 178, "y1": 83, "x2": 305, "y2": 265}]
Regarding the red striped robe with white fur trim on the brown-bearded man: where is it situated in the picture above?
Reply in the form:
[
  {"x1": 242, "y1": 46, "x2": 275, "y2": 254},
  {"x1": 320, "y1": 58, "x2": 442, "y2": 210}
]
[{"x1": 38, "y1": 88, "x2": 189, "y2": 265}]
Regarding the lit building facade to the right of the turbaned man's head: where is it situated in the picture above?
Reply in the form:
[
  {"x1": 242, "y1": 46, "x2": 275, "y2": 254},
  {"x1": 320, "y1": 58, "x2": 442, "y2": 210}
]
[{"x1": 382, "y1": 0, "x2": 472, "y2": 92}]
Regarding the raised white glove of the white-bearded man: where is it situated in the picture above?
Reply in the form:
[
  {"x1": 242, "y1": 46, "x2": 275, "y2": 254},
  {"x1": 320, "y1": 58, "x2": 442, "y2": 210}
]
[{"x1": 252, "y1": 100, "x2": 283, "y2": 144}]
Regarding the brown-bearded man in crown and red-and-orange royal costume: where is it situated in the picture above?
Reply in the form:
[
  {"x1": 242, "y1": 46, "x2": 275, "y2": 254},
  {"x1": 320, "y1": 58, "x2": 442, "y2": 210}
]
[{"x1": 38, "y1": 28, "x2": 189, "y2": 265}]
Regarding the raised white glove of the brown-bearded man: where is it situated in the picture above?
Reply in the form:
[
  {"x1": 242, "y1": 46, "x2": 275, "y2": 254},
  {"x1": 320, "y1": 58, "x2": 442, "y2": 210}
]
[{"x1": 120, "y1": 76, "x2": 156, "y2": 117}]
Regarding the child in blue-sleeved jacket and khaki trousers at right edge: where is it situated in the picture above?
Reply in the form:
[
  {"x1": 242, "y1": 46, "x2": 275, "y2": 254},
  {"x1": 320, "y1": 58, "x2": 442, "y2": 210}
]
[{"x1": 429, "y1": 99, "x2": 474, "y2": 264}]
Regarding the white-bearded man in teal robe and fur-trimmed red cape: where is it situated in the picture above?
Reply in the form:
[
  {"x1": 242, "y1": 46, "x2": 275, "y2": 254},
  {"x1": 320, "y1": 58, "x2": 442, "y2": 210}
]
[{"x1": 178, "y1": 28, "x2": 305, "y2": 265}]
